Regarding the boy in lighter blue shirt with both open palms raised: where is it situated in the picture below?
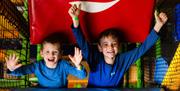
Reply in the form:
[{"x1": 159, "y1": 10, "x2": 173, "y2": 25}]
[{"x1": 6, "y1": 35, "x2": 86, "y2": 88}]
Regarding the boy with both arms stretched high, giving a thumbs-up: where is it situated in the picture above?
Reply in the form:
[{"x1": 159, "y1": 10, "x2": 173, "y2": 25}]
[{"x1": 68, "y1": 5, "x2": 167, "y2": 87}]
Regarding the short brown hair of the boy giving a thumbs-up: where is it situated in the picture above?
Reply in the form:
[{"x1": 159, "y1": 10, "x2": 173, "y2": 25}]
[{"x1": 98, "y1": 28, "x2": 122, "y2": 44}]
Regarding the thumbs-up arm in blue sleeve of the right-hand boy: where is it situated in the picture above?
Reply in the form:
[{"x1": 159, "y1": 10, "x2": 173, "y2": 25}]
[{"x1": 117, "y1": 11, "x2": 168, "y2": 72}]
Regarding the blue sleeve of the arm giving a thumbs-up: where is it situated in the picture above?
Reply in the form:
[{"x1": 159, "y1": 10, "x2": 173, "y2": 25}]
[{"x1": 118, "y1": 29, "x2": 159, "y2": 68}]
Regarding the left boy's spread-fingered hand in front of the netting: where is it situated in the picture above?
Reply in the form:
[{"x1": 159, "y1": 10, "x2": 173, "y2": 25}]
[{"x1": 5, "y1": 54, "x2": 22, "y2": 71}]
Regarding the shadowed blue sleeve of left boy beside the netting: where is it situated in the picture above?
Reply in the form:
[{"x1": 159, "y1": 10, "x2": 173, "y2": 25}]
[{"x1": 7, "y1": 63, "x2": 35, "y2": 76}]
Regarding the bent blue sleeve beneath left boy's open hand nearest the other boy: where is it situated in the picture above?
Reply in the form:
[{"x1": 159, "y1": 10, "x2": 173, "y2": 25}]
[{"x1": 62, "y1": 61, "x2": 87, "y2": 79}]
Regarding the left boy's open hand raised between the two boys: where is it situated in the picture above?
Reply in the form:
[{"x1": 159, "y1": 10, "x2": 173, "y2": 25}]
[{"x1": 69, "y1": 47, "x2": 82, "y2": 70}]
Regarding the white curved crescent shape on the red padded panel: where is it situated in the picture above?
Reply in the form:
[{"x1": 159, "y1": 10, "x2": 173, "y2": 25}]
[{"x1": 69, "y1": 0, "x2": 120, "y2": 13}]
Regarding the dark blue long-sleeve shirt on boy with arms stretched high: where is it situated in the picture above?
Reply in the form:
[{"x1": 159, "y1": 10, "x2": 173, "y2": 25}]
[{"x1": 72, "y1": 26, "x2": 158, "y2": 87}]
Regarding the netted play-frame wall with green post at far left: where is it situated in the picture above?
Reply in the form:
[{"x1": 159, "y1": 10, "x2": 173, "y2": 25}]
[{"x1": 0, "y1": 0, "x2": 29, "y2": 88}]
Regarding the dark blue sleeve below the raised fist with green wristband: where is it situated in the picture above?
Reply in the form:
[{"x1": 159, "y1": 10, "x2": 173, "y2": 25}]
[{"x1": 71, "y1": 25, "x2": 90, "y2": 61}]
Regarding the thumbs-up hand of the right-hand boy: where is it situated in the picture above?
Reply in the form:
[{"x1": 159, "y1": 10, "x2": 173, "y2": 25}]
[{"x1": 154, "y1": 11, "x2": 168, "y2": 33}]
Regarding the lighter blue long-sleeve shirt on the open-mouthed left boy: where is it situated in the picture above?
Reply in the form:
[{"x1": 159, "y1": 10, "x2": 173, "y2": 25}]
[{"x1": 8, "y1": 60, "x2": 86, "y2": 88}]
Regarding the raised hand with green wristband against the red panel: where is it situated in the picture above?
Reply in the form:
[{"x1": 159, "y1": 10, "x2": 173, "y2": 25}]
[{"x1": 68, "y1": 4, "x2": 81, "y2": 28}]
